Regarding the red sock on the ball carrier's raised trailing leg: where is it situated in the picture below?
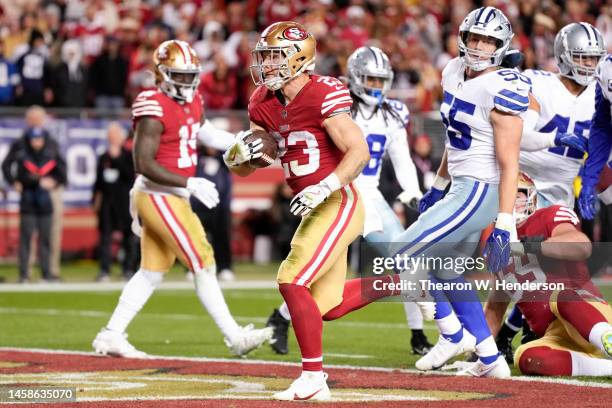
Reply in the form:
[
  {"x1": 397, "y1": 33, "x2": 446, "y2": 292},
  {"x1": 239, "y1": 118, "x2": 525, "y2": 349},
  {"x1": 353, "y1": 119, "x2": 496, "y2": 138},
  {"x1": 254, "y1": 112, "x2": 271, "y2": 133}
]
[{"x1": 323, "y1": 275, "x2": 400, "y2": 321}]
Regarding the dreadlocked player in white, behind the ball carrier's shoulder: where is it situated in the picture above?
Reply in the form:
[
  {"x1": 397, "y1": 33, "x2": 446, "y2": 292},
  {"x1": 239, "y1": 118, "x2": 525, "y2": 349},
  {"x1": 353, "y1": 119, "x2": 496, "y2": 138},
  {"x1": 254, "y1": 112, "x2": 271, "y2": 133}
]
[{"x1": 268, "y1": 47, "x2": 431, "y2": 355}]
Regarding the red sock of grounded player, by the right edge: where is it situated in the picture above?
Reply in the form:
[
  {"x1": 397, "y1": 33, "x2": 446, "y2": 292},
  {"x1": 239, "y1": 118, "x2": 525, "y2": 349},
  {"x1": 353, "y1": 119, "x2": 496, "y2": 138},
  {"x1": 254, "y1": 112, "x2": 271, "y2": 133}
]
[{"x1": 557, "y1": 290, "x2": 608, "y2": 341}]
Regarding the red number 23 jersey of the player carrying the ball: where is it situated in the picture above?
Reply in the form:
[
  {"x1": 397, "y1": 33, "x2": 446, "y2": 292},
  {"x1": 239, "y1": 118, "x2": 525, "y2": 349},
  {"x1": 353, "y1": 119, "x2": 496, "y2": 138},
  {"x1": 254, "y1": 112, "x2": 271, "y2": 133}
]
[{"x1": 249, "y1": 75, "x2": 353, "y2": 193}]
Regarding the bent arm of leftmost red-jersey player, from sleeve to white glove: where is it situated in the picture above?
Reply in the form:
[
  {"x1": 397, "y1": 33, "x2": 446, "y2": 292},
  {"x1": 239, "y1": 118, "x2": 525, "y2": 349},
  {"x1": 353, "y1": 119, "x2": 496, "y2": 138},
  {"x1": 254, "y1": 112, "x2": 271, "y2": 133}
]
[{"x1": 134, "y1": 117, "x2": 187, "y2": 187}]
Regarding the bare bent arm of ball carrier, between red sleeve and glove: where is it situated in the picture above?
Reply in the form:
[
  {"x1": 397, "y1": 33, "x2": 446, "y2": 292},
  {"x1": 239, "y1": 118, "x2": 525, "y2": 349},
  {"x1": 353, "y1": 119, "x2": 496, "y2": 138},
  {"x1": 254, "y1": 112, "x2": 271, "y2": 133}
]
[{"x1": 323, "y1": 113, "x2": 370, "y2": 186}]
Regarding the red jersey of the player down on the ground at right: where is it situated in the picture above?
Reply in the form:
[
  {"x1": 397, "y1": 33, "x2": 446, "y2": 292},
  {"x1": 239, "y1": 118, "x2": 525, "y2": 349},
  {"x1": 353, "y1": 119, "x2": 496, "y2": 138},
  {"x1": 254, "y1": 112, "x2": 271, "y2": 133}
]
[{"x1": 503, "y1": 205, "x2": 599, "y2": 336}]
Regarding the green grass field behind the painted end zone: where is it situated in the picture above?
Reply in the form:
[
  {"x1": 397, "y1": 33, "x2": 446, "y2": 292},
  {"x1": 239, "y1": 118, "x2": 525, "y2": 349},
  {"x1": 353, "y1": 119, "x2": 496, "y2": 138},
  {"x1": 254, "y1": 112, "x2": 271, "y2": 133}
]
[{"x1": 0, "y1": 264, "x2": 612, "y2": 382}]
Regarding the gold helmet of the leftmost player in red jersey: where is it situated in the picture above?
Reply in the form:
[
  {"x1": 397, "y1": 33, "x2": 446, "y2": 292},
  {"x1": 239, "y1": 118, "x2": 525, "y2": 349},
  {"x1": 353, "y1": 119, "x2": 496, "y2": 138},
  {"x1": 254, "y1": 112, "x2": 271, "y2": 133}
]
[{"x1": 153, "y1": 40, "x2": 202, "y2": 102}]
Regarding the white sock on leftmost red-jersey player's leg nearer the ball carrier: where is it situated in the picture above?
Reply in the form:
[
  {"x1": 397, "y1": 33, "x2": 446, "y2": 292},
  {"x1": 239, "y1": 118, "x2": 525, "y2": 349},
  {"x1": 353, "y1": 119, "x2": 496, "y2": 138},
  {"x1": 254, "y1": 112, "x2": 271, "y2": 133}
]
[{"x1": 193, "y1": 266, "x2": 240, "y2": 341}]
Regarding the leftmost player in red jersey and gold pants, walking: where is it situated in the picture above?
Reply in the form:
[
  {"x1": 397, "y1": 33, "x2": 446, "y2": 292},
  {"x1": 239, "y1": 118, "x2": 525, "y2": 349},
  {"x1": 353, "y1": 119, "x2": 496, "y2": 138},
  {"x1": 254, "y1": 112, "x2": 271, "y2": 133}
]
[{"x1": 92, "y1": 40, "x2": 272, "y2": 358}]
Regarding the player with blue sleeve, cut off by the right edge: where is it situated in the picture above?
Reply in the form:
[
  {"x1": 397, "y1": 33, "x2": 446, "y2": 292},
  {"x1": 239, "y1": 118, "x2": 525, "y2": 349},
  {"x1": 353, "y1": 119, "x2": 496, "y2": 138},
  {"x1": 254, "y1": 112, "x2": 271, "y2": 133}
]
[{"x1": 578, "y1": 55, "x2": 612, "y2": 220}]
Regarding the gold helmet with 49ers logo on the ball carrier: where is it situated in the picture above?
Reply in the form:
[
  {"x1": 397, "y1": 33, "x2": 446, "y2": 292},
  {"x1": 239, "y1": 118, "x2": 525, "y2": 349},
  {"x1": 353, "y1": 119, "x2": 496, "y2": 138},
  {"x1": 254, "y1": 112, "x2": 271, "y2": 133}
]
[{"x1": 251, "y1": 21, "x2": 317, "y2": 91}]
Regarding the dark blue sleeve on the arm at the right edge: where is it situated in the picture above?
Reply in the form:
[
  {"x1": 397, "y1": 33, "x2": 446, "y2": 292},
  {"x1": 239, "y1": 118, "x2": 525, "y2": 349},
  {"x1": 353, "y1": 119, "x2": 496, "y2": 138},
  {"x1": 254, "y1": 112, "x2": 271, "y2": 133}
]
[{"x1": 582, "y1": 83, "x2": 612, "y2": 190}]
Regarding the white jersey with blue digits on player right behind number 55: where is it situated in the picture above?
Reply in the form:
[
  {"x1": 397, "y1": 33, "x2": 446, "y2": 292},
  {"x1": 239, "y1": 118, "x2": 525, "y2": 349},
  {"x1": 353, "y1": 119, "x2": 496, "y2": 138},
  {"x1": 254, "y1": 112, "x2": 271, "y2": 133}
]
[{"x1": 519, "y1": 69, "x2": 595, "y2": 208}]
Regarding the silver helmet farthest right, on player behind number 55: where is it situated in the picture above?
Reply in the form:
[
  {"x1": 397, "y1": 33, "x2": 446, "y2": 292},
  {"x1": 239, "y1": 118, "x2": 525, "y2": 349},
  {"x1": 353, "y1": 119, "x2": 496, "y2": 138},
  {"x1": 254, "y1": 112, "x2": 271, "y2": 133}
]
[{"x1": 554, "y1": 23, "x2": 606, "y2": 86}]
